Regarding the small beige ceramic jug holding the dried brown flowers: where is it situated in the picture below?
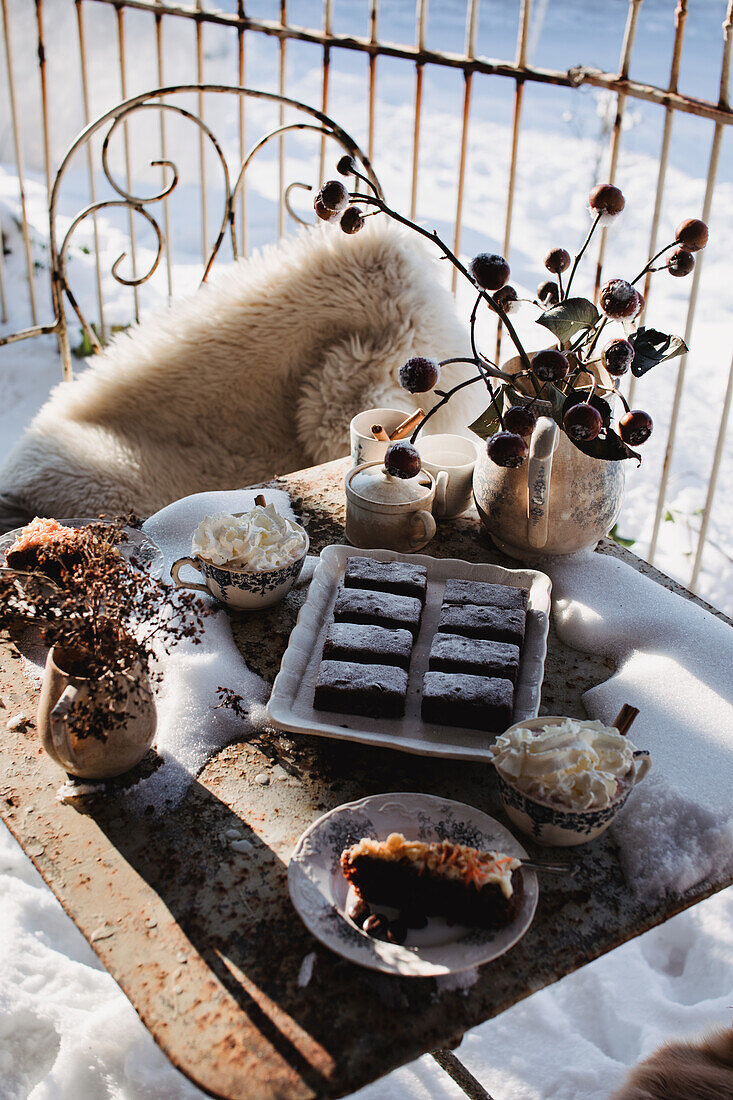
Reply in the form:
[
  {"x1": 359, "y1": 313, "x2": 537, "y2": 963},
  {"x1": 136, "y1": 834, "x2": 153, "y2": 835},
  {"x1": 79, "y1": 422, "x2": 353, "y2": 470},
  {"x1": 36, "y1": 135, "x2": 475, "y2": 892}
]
[{"x1": 37, "y1": 646, "x2": 157, "y2": 779}]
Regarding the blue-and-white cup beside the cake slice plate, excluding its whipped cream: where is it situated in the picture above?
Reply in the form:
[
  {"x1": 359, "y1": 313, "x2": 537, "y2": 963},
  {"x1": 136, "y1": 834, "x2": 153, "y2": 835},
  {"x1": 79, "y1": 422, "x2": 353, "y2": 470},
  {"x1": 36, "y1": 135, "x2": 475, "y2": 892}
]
[{"x1": 494, "y1": 715, "x2": 652, "y2": 847}]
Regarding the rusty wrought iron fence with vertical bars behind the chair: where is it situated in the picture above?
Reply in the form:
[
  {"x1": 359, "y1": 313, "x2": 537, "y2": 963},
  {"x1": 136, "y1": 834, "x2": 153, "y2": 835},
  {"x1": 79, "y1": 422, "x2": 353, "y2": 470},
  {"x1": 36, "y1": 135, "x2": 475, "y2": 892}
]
[{"x1": 0, "y1": 0, "x2": 733, "y2": 587}]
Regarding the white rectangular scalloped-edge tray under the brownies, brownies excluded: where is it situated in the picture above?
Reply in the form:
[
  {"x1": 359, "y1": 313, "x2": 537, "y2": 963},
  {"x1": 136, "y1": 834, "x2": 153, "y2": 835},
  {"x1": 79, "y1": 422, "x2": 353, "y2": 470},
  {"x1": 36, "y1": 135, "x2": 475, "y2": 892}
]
[{"x1": 267, "y1": 546, "x2": 550, "y2": 761}]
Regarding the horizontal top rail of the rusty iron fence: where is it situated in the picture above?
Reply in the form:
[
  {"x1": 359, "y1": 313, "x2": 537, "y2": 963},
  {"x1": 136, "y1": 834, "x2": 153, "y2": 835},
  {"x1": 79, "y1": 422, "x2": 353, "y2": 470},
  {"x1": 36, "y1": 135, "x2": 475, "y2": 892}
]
[{"x1": 77, "y1": 0, "x2": 733, "y2": 125}]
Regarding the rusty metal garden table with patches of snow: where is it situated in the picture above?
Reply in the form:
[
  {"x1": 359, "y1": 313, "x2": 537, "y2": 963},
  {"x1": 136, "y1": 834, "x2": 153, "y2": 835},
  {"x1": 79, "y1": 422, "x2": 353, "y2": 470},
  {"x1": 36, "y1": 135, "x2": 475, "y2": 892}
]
[{"x1": 0, "y1": 461, "x2": 727, "y2": 1100}]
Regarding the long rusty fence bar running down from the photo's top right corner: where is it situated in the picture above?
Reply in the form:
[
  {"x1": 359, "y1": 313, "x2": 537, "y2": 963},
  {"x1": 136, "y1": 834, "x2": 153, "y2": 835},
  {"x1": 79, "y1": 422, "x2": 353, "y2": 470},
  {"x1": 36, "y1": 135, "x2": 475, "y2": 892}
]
[{"x1": 647, "y1": 0, "x2": 733, "y2": 564}]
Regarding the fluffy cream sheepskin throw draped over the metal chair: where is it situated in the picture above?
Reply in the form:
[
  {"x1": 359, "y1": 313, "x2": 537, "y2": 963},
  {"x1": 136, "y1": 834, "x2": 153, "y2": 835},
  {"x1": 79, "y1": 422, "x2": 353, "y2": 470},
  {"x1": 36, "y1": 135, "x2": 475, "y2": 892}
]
[{"x1": 0, "y1": 218, "x2": 473, "y2": 528}]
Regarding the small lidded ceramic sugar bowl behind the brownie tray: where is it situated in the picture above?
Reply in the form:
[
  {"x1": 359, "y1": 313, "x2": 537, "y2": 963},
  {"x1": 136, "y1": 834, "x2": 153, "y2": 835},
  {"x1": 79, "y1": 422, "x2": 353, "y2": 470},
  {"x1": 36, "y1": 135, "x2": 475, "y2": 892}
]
[{"x1": 344, "y1": 462, "x2": 446, "y2": 553}]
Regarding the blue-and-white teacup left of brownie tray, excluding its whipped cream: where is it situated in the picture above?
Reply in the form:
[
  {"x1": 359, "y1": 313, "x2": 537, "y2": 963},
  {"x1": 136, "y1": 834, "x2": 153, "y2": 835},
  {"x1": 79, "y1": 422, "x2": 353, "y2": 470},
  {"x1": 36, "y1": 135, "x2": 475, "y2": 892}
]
[{"x1": 171, "y1": 528, "x2": 309, "y2": 612}]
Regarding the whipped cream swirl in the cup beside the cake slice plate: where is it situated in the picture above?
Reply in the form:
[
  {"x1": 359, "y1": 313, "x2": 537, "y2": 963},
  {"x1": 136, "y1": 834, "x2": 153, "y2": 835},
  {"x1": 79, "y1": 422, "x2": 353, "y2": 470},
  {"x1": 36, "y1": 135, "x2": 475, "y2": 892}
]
[{"x1": 492, "y1": 718, "x2": 636, "y2": 810}]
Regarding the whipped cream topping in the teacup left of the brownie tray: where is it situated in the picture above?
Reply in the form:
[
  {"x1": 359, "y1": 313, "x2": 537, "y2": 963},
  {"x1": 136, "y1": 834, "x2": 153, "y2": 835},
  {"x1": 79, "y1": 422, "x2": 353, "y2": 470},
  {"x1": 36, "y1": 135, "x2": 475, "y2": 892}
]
[{"x1": 192, "y1": 504, "x2": 306, "y2": 573}]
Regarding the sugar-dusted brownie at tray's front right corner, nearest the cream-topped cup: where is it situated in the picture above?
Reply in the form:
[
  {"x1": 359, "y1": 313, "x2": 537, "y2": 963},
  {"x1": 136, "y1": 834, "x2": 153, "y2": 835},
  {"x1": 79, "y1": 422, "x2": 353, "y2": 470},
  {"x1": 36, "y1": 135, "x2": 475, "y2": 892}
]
[{"x1": 422, "y1": 672, "x2": 514, "y2": 734}]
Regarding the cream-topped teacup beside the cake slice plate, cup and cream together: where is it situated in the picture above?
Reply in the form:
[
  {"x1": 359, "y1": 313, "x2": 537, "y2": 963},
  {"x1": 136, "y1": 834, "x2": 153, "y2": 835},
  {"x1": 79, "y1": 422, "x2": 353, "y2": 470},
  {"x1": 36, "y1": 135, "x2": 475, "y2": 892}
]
[{"x1": 492, "y1": 716, "x2": 652, "y2": 846}]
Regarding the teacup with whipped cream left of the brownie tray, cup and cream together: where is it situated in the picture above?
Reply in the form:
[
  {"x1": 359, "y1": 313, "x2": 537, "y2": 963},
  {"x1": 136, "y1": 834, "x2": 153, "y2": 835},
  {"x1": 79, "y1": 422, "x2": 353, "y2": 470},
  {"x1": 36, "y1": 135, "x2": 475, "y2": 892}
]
[{"x1": 171, "y1": 498, "x2": 308, "y2": 611}]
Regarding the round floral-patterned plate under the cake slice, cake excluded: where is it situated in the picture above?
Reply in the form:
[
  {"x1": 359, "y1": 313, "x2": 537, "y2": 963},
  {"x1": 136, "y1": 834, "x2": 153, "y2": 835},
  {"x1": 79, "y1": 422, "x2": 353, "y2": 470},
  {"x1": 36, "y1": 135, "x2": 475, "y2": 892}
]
[{"x1": 287, "y1": 793, "x2": 538, "y2": 978}]
